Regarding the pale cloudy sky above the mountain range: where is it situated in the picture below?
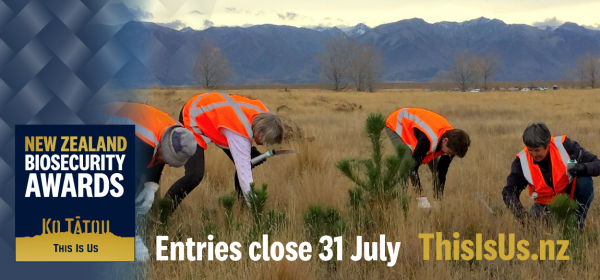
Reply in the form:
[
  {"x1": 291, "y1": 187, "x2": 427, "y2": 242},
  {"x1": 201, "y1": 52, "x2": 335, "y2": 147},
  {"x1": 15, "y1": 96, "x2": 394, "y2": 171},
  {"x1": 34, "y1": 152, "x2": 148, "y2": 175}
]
[{"x1": 123, "y1": 0, "x2": 600, "y2": 30}]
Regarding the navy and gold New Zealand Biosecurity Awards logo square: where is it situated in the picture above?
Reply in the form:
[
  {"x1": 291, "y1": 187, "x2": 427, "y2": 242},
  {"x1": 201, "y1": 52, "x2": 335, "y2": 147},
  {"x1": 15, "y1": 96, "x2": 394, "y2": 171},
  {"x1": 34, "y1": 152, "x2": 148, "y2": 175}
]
[{"x1": 15, "y1": 125, "x2": 135, "y2": 261}]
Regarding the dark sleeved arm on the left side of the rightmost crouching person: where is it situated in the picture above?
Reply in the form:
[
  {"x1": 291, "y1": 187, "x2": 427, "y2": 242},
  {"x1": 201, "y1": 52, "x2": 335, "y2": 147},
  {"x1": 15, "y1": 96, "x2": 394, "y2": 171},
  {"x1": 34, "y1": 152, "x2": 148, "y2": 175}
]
[{"x1": 502, "y1": 158, "x2": 528, "y2": 218}]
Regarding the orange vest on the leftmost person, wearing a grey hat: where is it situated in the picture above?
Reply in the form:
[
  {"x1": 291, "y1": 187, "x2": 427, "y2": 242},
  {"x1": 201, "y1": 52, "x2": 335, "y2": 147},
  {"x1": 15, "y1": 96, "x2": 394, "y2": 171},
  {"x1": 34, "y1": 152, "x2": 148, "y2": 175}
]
[{"x1": 94, "y1": 102, "x2": 180, "y2": 165}]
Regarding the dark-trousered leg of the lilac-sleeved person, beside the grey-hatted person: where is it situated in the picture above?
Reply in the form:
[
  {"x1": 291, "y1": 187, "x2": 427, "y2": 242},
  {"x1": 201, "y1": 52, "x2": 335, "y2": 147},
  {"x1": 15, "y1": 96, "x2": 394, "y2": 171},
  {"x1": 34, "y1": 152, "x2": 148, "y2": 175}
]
[{"x1": 165, "y1": 146, "x2": 204, "y2": 211}]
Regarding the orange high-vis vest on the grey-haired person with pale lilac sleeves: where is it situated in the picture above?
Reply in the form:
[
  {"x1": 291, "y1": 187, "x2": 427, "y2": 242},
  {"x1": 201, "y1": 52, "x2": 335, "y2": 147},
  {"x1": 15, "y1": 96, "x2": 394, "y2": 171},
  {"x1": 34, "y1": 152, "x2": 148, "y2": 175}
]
[{"x1": 182, "y1": 92, "x2": 268, "y2": 149}]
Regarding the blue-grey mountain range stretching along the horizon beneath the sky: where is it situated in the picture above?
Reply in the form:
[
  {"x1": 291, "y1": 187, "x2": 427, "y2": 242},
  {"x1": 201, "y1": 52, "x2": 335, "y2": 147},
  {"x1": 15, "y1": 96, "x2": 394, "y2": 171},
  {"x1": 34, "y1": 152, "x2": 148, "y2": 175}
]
[{"x1": 110, "y1": 18, "x2": 600, "y2": 87}]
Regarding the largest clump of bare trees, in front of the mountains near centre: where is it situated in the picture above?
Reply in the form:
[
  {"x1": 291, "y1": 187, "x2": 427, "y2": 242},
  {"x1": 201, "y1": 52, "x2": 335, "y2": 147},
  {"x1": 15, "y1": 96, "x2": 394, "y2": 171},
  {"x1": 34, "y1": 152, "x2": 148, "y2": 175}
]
[{"x1": 317, "y1": 36, "x2": 383, "y2": 92}]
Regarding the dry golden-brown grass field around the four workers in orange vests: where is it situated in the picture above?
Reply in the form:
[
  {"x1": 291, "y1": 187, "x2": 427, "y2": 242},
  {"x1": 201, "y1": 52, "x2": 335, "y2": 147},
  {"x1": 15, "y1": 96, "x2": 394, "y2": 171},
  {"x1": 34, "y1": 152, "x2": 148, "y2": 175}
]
[{"x1": 140, "y1": 89, "x2": 600, "y2": 279}]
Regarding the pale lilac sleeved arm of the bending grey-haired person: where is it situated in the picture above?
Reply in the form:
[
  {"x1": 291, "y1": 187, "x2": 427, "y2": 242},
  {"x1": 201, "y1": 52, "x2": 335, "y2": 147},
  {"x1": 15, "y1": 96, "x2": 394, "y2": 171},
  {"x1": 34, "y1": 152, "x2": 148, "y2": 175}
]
[{"x1": 221, "y1": 128, "x2": 253, "y2": 201}]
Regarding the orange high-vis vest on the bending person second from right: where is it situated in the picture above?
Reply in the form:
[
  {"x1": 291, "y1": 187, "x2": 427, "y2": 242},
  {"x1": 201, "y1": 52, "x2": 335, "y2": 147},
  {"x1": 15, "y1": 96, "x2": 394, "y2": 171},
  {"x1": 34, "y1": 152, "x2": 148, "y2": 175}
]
[{"x1": 386, "y1": 108, "x2": 452, "y2": 163}]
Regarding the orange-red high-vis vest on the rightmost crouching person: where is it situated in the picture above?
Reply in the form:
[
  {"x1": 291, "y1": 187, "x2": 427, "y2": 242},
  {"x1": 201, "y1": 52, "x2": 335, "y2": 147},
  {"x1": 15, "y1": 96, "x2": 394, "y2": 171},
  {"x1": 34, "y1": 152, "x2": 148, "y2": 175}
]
[{"x1": 517, "y1": 135, "x2": 570, "y2": 205}]
